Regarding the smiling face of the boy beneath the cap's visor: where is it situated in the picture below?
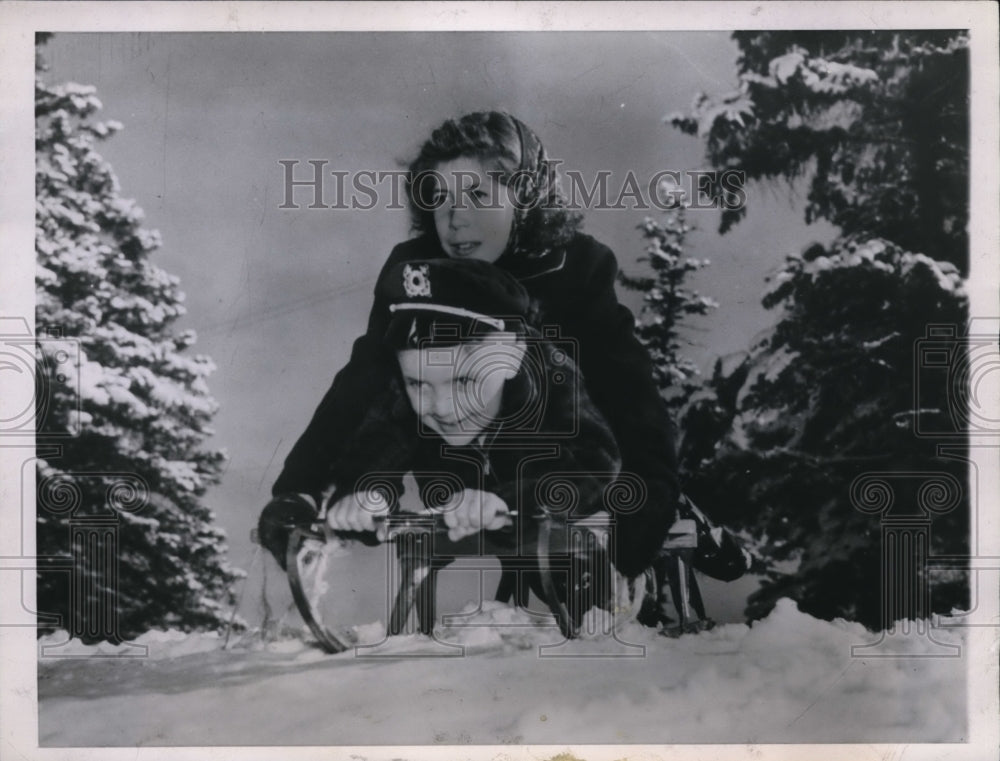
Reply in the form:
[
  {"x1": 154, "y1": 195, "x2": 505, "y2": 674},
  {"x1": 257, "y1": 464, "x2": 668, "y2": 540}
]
[{"x1": 396, "y1": 342, "x2": 520, "y2": 446}]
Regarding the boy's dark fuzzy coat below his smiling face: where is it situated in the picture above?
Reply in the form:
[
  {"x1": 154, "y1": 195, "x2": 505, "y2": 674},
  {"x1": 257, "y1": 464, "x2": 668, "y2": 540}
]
[{"x1": 329, "y1": 337, "x2": 621, "y2": 518}]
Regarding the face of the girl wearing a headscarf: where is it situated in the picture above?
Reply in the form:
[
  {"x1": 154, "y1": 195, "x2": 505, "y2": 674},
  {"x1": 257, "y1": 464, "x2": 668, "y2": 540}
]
[{"x1": 432, "y1": 156, "x2": 514, "y2": 263}]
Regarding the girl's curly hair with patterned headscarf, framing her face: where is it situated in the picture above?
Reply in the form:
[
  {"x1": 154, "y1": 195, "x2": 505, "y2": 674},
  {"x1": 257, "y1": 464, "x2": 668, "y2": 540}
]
[{"x1": 406, "y1": 111, "x2": 583, "y2": 257}]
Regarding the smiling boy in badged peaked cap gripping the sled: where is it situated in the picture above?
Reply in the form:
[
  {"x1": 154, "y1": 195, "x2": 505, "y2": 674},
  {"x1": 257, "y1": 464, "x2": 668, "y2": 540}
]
[{"x1": 260, "y1": 259, "x2": 620, "y2": 596}]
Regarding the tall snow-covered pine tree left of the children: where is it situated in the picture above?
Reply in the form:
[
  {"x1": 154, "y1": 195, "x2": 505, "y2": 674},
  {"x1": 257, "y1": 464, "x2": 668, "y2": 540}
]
[{"x1": 35, "y1": 39, "x2": 241, "y2": 639}]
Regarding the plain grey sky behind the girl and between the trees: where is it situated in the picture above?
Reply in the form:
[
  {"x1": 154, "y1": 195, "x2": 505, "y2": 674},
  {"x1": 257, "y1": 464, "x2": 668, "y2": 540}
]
[{"x1": 45, "y1": 32, "x2": 831, "y2": 620}]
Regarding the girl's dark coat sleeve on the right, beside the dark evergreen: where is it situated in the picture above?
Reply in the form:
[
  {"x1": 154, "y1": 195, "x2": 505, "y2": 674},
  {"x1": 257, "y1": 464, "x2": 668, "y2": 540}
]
[{"x1": 574, "y1": 239, "x2": 679, "y2": 576}]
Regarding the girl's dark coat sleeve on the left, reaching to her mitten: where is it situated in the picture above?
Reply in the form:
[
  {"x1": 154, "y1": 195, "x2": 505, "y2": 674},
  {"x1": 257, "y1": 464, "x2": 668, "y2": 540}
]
[{"x1": 271, "y1": 243, "x2": 411, "y2": 500}]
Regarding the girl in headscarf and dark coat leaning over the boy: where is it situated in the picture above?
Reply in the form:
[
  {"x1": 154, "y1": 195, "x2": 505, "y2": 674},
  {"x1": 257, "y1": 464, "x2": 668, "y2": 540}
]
[{"x1": 260, "y1": 111, "x2": 679, "y2": 577}]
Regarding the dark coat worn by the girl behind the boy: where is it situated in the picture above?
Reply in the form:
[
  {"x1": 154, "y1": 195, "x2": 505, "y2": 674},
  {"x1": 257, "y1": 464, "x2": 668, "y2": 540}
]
[{"x1": 273, "y1": 233, "x2": 679, "y2": 576}]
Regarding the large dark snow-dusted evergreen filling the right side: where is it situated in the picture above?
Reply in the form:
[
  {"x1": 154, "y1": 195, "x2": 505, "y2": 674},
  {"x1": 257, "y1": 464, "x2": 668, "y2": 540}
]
[{"x1": 671, "y1": 30, "x2": 969, "y2": 628}]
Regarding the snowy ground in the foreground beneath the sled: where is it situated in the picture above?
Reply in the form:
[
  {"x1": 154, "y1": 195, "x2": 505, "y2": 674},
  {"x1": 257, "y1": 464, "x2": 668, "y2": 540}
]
[{"x1": 38, "y1": 601, "x2": 968, "y2": 758}]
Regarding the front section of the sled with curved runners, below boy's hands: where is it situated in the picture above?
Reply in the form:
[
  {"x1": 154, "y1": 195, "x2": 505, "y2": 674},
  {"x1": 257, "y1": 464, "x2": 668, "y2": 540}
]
[{"x1": 286, "y1": 514, "x2": 614, "y2": 653}]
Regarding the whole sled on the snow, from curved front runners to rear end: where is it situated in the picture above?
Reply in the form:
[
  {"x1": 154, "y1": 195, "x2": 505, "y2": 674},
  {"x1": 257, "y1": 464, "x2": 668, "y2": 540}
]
[{"x1": 276, "y1": 497, "x2": 750, "y2": 653}]
